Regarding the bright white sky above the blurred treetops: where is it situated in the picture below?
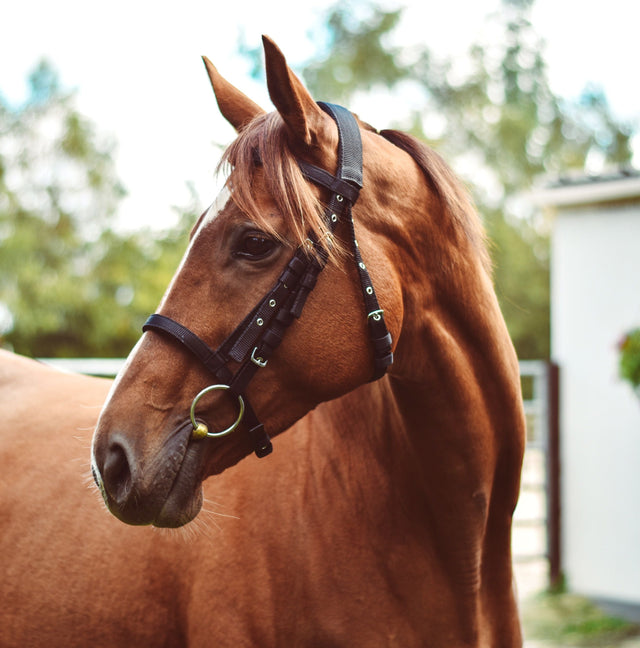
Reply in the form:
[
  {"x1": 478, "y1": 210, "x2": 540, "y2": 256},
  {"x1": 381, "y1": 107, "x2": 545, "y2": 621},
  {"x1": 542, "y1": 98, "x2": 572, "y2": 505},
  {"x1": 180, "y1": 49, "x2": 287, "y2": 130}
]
[{"x1": 0, "y1": 0, "x2": 640, "y2": 230}]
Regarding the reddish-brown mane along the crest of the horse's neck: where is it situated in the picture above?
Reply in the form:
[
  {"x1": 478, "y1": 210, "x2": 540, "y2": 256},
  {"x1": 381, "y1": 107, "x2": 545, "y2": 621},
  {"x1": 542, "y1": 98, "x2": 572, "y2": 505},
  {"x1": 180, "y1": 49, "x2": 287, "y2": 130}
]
[{"x1": 378, "y1": 130, "x2": 491, "y2": 275}]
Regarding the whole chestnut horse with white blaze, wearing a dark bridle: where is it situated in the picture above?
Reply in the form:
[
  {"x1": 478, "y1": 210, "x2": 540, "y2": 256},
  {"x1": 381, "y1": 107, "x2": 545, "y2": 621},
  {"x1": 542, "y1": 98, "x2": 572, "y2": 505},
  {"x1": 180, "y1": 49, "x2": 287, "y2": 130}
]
[{"x1": 0, "y1": 37, "x2": 525, "y2": 648}]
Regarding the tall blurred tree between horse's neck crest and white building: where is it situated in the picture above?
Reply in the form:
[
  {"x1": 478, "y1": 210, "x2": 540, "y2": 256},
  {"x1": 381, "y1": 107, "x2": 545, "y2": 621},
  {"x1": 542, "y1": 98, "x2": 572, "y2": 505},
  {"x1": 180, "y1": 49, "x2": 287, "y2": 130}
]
[{"x1": 414, "y1": 0, "x2": 632, "y2": 358}]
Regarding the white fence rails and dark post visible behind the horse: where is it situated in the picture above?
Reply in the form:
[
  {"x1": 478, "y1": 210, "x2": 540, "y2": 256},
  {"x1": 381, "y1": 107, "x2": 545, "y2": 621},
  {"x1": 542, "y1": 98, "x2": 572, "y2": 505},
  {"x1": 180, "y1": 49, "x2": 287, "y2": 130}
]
[{"x1": 41, "y1": 358, "x2": 561, "y2": 595}]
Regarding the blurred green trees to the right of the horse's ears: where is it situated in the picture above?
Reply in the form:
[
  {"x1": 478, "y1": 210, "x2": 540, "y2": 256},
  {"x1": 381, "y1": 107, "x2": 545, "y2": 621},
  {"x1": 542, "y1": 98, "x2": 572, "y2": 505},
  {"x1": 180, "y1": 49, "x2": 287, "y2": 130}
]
[{"x1": 278, "y1": 0, "x2": 632, "y2": 358}]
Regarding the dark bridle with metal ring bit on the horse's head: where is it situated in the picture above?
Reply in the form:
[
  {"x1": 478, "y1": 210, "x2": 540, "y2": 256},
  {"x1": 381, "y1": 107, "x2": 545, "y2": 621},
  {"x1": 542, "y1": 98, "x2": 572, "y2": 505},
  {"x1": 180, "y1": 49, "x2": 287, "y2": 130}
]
[{"x1": 142, "y1": 103, "x2": 393, "y2": 457}]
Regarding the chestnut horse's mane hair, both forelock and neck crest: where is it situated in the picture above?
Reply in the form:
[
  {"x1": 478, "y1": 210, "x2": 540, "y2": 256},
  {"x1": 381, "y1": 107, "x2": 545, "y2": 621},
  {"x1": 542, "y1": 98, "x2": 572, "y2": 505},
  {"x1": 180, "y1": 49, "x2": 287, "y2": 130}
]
[{"x1": 218, "y1": 112, "x2": 491, "y2": 273}]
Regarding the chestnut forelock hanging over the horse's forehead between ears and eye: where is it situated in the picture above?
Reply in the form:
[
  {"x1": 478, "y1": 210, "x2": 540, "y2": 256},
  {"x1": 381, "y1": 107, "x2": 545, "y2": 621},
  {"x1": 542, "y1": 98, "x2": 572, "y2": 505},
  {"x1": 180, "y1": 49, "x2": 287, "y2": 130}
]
[{"x1": 219, "y1": 112, "x2": 327, "y2": 253}]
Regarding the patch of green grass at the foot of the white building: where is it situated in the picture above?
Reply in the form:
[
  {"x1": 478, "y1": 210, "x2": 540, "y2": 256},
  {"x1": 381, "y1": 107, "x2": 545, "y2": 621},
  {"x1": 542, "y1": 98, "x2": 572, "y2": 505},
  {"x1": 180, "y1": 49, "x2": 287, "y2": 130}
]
[{"x1": 522, "y1": 592, "x2": 640, "y2": 648}]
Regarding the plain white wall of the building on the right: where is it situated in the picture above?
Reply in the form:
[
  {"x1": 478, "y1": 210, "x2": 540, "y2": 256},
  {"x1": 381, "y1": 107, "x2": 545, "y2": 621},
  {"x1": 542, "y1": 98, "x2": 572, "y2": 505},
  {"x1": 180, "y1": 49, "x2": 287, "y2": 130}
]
[{"x1": 551, "y1": 201, "x2": 640, "y2": 606}]
